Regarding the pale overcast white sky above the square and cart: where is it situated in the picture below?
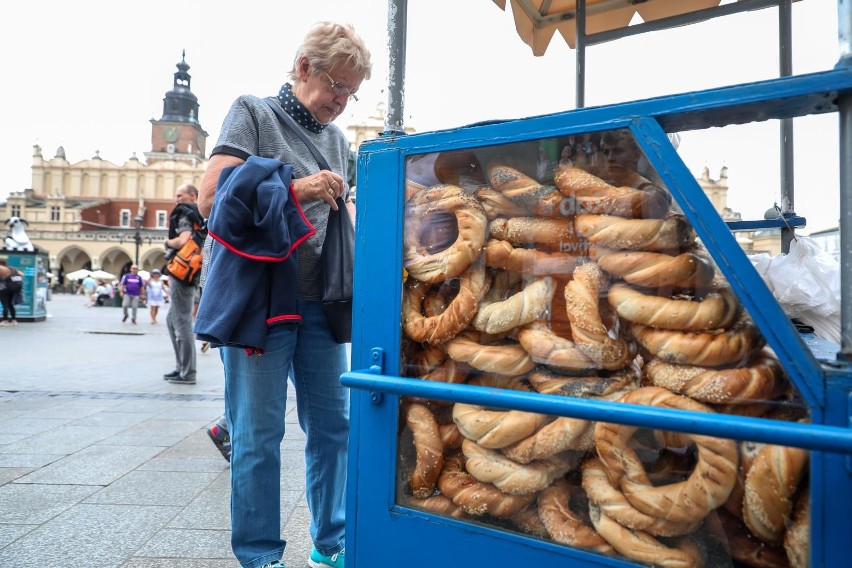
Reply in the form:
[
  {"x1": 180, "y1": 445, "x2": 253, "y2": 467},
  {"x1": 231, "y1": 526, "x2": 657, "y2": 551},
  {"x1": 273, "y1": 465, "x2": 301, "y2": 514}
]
[{"x1": 0, "y1": 0, "x2": 839, "y2": 233}]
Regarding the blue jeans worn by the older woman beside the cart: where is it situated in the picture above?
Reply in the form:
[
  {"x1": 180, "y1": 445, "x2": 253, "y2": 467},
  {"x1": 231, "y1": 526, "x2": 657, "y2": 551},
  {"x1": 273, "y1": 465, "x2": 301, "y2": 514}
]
[{"x1": 225, "y1": 301, "x2": 349, "y2": 568}]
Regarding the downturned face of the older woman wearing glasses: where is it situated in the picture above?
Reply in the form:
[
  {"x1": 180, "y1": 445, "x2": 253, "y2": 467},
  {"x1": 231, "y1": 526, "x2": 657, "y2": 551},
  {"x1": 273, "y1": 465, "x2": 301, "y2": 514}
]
[{"x1": 294, "y1": 59, "x2": 364, "y2": 124}]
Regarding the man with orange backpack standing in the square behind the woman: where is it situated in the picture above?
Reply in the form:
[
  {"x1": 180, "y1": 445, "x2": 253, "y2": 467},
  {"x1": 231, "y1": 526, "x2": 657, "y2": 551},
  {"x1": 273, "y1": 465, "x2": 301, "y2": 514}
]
[{"x1": 163, "y1": 183, "x2": 206, "y2": 385}]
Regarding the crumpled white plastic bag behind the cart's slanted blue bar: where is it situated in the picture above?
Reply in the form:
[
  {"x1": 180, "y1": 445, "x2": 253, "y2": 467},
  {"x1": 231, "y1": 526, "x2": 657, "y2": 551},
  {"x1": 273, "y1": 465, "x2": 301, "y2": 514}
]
[{"x1": 749, "y1": 236, "x2": 840, "y2": 343}]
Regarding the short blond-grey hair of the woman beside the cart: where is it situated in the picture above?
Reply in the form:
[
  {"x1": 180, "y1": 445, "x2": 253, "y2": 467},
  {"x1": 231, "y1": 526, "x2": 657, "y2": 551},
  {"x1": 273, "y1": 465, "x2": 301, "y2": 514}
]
[{"x1": 290, "y1": 22, "x2": 373, "y2": 83}]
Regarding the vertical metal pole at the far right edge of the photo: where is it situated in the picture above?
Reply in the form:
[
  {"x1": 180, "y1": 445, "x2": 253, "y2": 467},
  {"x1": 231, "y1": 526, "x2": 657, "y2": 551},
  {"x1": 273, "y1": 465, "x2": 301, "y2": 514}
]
[{"x1": 837, "y1": 0, "x2": 852, "y2": 361}]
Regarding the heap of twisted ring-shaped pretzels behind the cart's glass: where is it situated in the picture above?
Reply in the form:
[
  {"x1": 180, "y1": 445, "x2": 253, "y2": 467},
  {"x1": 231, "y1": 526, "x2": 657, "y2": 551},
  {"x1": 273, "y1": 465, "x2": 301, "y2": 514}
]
[{"x1": 399, "y1": 161, "x2": 809, "y2": 567}]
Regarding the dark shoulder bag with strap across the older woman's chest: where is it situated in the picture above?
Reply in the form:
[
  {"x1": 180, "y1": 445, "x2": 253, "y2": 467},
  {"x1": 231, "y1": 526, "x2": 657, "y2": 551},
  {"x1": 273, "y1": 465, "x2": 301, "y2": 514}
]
[{"x1": 266, "y1": 97, "x2": 355, "y2": 343}]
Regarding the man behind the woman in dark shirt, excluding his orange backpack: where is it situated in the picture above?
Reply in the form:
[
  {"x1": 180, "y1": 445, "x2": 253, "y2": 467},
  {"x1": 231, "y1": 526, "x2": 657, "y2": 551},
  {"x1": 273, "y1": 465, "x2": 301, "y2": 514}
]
[{"x1": 163, "y1": 183, "x2": 204, "y2": 385}]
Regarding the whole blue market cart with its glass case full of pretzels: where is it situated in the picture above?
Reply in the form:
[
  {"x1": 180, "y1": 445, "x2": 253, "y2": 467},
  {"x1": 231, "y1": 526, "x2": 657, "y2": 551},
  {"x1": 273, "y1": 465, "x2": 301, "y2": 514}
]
[{"x1": 342, "y1": 2, "x2": 852, "y2": 568}]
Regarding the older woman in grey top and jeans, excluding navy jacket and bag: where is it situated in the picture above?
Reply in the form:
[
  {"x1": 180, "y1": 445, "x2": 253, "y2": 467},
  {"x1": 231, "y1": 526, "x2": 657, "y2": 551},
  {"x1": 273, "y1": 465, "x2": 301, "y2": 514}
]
[{"x1": 198, "y1": 22, "x2": 372, "y2": 568}]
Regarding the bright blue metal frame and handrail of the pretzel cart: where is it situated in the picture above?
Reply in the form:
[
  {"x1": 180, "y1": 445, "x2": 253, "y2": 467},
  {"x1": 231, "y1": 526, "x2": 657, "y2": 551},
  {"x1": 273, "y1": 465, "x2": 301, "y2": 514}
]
[{"x1": 342, "y1": 69, "x2": 852, "y2": 568}]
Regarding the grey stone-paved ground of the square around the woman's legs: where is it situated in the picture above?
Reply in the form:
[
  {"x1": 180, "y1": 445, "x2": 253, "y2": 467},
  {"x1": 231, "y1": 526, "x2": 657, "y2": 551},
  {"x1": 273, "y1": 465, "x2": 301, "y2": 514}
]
[{"x1": 0, "y1": 294, "x2": 310, "y2": 568}]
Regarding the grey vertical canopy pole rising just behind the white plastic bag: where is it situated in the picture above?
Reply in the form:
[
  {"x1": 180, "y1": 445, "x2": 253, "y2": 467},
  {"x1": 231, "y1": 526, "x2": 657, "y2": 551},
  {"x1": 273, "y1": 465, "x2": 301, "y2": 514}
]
[{"x1": 778, "y1": 0, "x2": 796, "y2": 253}]
